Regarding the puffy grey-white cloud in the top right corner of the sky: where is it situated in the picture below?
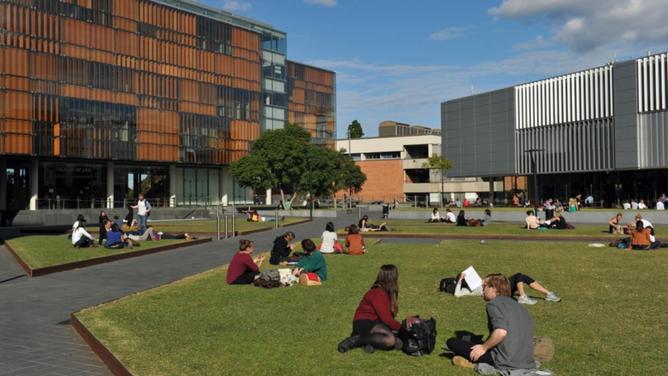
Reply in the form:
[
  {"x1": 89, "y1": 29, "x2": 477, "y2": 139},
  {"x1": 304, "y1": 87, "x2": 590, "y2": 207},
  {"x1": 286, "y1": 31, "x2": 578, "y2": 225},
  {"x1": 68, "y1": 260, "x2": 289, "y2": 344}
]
[{"x1": 489, "y1": 0, "x2": 668, "y2": 52}]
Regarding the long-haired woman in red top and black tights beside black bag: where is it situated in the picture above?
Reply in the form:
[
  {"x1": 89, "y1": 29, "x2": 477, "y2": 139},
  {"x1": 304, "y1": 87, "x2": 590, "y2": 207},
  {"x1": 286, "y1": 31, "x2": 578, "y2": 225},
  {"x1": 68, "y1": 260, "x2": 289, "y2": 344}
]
[{"x1": 338, "y1": 265, "x2": 415, "y2": 353}]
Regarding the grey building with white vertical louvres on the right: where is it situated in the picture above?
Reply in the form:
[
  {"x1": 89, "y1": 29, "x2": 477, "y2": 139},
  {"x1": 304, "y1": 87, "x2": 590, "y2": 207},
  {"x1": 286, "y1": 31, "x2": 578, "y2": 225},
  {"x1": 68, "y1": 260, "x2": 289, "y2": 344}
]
[{"x1": 441, "y1": 53, "x2": 668, "y2": 205}]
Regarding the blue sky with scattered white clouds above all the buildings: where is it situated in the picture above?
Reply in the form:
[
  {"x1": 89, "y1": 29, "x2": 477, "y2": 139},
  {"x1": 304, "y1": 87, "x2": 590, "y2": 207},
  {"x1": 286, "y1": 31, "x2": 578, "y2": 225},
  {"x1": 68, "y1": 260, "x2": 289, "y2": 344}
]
[{"x1": 201, "y1": 0, "x2": 668, "y2": 138}]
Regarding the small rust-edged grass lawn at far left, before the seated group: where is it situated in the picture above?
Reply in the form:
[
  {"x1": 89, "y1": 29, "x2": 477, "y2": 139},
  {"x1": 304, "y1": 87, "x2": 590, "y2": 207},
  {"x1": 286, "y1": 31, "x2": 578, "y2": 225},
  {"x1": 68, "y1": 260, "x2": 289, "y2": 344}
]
[{"x1": 6, "y1": 235, "x2": 193, "y2": 269}]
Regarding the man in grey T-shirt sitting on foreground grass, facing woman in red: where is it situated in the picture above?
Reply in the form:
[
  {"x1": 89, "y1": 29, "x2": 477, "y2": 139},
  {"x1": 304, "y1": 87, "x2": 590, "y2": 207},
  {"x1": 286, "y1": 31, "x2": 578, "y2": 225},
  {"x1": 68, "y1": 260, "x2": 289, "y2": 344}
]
[{"x1": 446, "y1": 274, "x2": 536, "y2": 372}]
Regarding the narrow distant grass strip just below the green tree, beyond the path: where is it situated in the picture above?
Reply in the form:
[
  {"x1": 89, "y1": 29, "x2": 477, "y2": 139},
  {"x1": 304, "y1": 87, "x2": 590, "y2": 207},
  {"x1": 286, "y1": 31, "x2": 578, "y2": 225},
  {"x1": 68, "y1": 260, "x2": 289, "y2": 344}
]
[{"x1": 88, "y1": 217, "x2": 306, "y2": 233}]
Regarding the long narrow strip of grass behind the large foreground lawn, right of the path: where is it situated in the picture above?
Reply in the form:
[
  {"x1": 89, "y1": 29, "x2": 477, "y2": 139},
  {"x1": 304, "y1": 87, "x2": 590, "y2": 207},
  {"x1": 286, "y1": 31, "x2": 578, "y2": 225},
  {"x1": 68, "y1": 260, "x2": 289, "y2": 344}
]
[{"x1": 339, "y1": 219, "x2": 668, "y2": 239}]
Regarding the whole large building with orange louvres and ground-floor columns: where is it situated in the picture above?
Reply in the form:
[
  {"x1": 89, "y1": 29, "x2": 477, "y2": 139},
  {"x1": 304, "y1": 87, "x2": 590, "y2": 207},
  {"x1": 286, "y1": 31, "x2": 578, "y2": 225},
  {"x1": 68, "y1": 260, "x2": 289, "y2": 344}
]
[{"x1": 0, "y1": 0, "x2": 336, "y2": 214}]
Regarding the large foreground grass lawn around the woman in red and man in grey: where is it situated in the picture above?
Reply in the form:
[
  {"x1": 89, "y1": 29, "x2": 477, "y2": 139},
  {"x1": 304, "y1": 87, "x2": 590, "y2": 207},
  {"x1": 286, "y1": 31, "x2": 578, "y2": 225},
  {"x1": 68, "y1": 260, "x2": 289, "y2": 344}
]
[{"x1": 77, "y1": 241, "x2": 668, "y2": 375}]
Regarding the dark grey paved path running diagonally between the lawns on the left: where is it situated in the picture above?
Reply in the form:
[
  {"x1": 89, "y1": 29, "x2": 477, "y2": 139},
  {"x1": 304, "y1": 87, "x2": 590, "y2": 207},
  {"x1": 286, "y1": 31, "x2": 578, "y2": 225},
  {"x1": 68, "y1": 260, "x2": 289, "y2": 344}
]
[{"x1": 0, "y1": 216, "x2": 420, "y2": 376}]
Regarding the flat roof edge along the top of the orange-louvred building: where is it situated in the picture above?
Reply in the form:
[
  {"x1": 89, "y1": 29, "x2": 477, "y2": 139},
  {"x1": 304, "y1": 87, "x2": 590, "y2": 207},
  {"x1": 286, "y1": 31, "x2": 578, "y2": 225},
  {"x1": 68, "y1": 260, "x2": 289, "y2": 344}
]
[{"x1": 151, "y1": 0, "x2": 286, "y2": 38}]
